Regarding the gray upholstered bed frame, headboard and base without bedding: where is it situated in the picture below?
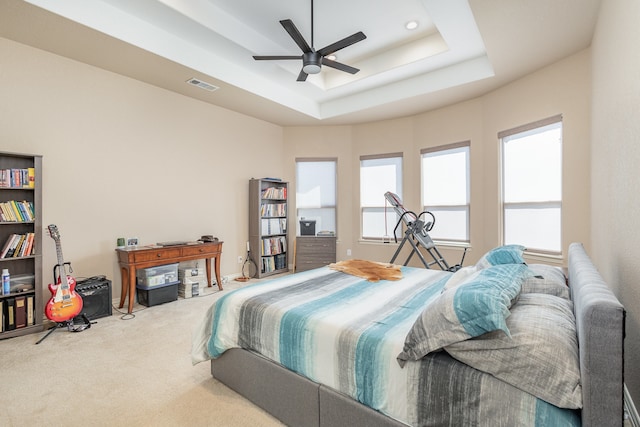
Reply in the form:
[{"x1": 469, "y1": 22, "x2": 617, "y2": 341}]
[{"x1": 211, "y1": 243, "x2": 625, "y2": 427}]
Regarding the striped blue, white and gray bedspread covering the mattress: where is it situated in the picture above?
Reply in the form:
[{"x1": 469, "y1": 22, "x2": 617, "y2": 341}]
[{"x1": 192, "y1": 267, "x2": 580, "y2": 426}]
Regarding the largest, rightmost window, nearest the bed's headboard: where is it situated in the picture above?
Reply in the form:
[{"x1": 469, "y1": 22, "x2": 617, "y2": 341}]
[{"x1": 498, "y1": 116, "x2": 562, "y2": 254}]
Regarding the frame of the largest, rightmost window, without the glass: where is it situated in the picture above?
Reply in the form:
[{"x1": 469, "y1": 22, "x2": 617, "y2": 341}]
[{"x1": 498, "y1": 114, "x2": 564, "y2": 256}]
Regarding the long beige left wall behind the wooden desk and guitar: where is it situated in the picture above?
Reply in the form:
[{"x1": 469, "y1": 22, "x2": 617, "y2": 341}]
[{"x1": 0, "y1": 39, "x2": 283, "y2": 296}]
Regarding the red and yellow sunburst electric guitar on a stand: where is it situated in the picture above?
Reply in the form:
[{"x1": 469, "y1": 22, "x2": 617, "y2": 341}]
[{"x1": 44, "y1": 224, "x2": 82, "y2": 323}]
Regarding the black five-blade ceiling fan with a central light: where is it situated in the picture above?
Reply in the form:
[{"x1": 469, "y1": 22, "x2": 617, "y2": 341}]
[{"x1": 253, "y1": 0, "x2": 367, "y2": 82}]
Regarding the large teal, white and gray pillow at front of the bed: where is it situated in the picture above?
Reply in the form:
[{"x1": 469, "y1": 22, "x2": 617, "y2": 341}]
[{"x1": 397, "y1": 264, "x2": 533, "y2": 366}]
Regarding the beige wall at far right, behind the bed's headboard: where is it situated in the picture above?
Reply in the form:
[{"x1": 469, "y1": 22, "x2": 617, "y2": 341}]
[{"x1": 591, "y1": 0, "x2": 640, "y2": 406}]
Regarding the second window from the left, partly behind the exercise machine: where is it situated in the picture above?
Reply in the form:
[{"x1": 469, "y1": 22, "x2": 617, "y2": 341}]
[{"x1": 360, "y1": 153, "x2": 402, "y2": 240}]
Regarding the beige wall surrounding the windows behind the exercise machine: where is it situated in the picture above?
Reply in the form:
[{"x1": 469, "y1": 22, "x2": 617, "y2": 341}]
[{"x1": 284, "y1": 50, "x2": 591, "y2": 265}]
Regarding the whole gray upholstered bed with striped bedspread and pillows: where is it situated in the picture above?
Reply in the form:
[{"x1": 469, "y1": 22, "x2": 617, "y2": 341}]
[{"x1": 192, "y1": 243, "x2": 625, "y2": 426}]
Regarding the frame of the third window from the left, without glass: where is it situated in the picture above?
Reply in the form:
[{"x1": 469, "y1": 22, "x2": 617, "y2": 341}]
[{"x1": 420, "y1": 140, "x2": 471, "y2": 244}]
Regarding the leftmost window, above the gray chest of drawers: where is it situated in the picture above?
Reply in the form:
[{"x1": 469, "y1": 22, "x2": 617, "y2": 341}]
[{"x1": 296, "y1": 159, "x2": 336, "y2": 235}]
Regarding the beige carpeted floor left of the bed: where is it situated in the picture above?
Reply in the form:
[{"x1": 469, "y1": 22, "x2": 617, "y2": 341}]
[{"x1": 0, "y1": 281, "x2": 282, "y2": 427}]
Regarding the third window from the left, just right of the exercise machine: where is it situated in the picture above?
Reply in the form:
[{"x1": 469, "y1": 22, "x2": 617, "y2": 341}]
[{"x1": 416, "y1": 141, "x2": 470, "y2": 242}]
